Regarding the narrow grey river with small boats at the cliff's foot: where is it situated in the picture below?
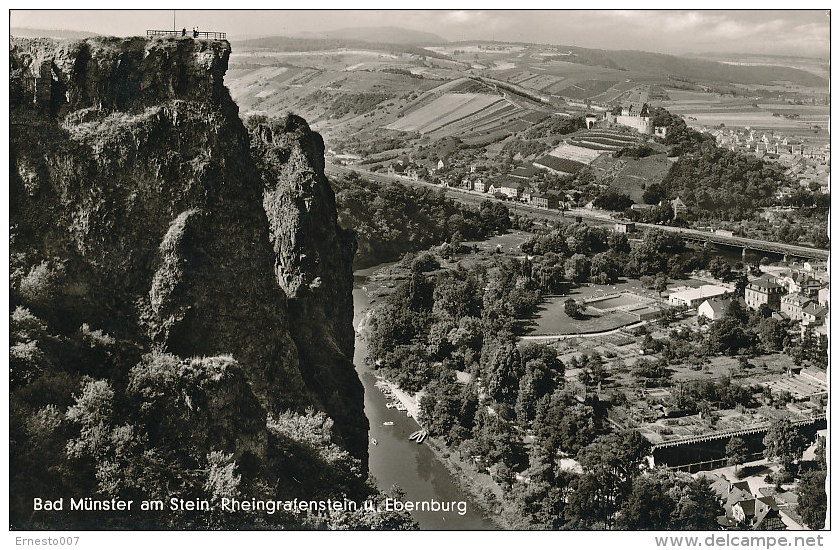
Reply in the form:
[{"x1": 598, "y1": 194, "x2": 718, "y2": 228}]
[{"x1": 353, "y1": 266, "x2": 497, "y2": 530}]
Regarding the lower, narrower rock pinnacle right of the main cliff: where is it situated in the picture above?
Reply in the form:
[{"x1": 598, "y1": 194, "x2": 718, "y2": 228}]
[{"x1": 251, "y1": 116, "x2": 367, "y2": 462}]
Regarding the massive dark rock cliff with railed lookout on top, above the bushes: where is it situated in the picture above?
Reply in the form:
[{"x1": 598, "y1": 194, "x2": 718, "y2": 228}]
[{"x1": 10, "y1": 38, "x2": 367, "y2": 464}]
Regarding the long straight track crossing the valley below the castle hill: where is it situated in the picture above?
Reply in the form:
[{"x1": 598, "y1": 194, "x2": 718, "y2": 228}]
[{"x1": 324, "y1": 162, "x2": 828, "y2": 260}]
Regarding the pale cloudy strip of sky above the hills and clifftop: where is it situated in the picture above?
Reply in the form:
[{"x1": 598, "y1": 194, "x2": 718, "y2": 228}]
[{"x1": 10, "y1": 8, "x2": 829, "y2": 59}]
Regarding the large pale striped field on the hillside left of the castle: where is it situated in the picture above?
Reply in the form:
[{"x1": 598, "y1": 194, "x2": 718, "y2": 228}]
[{"x1": 385, "y1": 93, "x2": 517, "y2": 134}]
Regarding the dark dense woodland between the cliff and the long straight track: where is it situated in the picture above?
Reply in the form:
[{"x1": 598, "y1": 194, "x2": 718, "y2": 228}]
[{"x1": 332, "y1": 173, "x2": 511, "y2": 268}]
